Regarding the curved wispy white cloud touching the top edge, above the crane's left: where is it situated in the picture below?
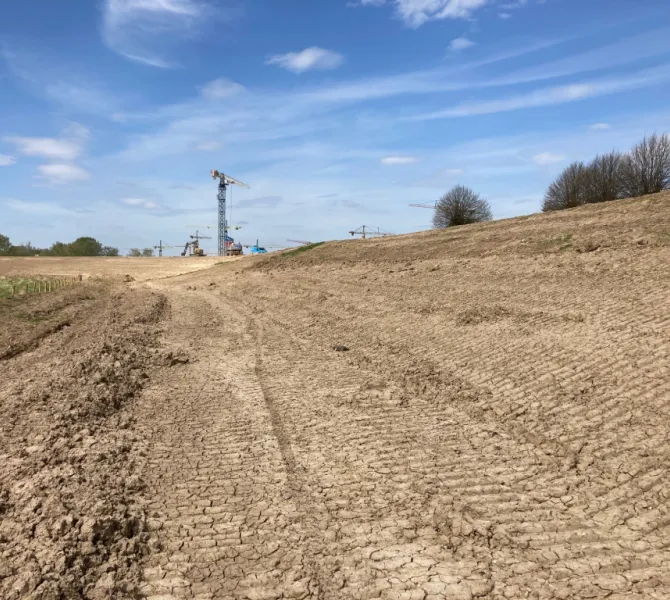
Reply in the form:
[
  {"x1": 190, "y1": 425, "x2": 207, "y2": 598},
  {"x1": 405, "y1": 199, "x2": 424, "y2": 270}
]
[{"x1": 102, "y1": 0, "x2": 213, "y2": 68}]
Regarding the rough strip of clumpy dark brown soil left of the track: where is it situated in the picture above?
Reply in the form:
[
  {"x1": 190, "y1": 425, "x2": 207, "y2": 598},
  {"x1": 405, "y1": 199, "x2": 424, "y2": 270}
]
[{"x1": 0, "y1": 282, "x2": 173, "y2": 600}]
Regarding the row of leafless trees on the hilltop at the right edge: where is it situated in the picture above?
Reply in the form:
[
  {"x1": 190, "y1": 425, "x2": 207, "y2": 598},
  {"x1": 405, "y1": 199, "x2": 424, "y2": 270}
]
[{"x1": 542, "y1": 134, "x2": 670, "y2": 212}]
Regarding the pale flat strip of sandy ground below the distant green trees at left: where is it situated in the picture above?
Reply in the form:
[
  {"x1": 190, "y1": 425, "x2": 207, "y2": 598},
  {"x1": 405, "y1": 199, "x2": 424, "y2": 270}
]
[{"x1": 0, "y1": 256, "x2": 239, "y2": 281}]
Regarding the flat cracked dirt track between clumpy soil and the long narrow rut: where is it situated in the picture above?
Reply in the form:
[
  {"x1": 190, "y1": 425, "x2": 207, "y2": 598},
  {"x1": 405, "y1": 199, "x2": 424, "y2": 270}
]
[{"x1": 136, "y1": 294, "x2": 318, "y2": 600}]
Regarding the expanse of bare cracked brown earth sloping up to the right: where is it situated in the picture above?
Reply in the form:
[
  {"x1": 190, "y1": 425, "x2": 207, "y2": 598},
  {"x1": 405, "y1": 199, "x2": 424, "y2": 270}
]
[{"x1": 0, "y1": 194, "x2": 670, "y2": 600}]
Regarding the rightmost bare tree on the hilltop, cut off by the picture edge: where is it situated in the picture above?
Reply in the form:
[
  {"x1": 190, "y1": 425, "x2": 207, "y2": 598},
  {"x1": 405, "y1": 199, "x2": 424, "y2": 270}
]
[{"x1": 621, "y1": 133, "x2": 670, "y2": 198}]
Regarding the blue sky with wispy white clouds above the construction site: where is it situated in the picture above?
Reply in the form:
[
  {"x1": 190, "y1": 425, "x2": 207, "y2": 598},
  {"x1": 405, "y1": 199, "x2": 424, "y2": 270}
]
[{"x1": 0, "y1": 0, "x2": 670, "y2": 253}]
